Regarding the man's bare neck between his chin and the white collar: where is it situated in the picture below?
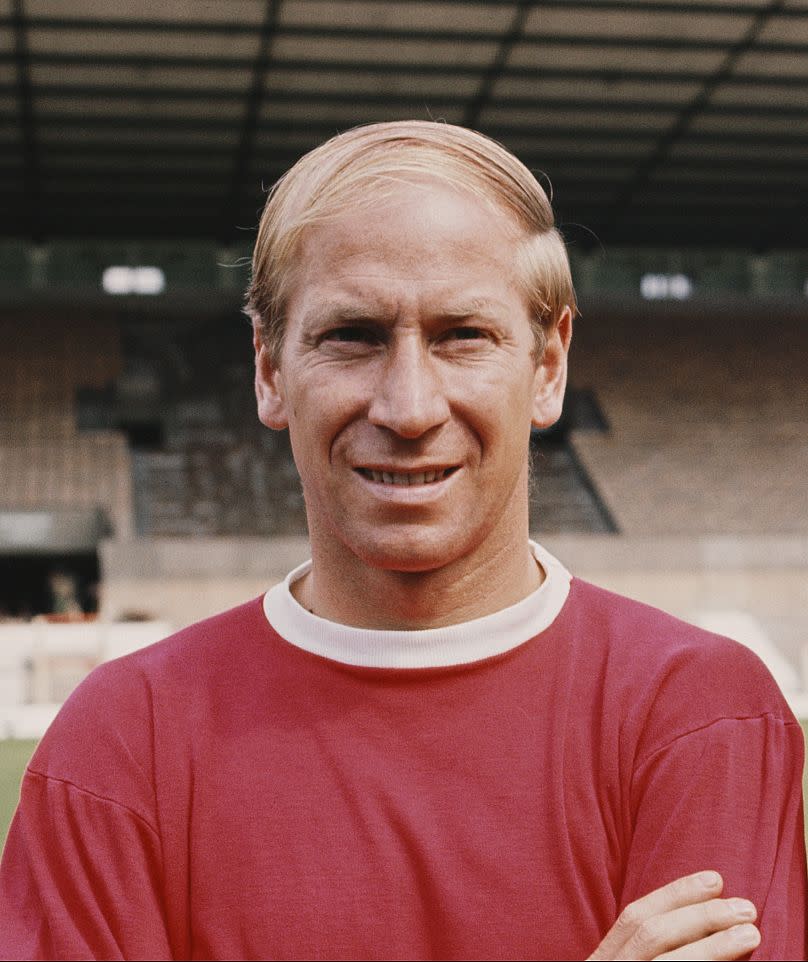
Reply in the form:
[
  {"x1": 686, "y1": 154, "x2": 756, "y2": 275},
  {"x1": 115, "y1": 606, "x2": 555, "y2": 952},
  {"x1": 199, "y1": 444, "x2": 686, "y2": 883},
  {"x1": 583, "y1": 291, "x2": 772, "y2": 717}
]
[{"x1": 293, "y1": 506, "x2": 544, "y2": 630}]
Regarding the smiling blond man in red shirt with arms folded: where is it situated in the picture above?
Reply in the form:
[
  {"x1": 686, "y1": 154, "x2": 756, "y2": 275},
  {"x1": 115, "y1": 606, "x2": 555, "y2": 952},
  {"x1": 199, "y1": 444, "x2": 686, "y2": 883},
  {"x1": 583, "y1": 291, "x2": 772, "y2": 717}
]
[{"x1": 0, "y1": 122, "x2": 806, "y2": 959}]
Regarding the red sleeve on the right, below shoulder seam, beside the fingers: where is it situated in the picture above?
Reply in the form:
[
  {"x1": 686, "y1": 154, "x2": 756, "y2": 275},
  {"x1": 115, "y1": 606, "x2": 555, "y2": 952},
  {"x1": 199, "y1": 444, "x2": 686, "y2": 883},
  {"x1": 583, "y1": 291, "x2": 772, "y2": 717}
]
[{"x1": 621, "y1": 714, "x2": 808, "y2": 959}]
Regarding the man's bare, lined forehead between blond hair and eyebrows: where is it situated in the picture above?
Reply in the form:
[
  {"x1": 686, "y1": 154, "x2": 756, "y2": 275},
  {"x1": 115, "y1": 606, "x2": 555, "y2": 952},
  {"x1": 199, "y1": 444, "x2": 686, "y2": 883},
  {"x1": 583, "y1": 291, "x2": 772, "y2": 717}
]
[{"x1": 289, "y1": 182, "x2": 524, "y2": 311}]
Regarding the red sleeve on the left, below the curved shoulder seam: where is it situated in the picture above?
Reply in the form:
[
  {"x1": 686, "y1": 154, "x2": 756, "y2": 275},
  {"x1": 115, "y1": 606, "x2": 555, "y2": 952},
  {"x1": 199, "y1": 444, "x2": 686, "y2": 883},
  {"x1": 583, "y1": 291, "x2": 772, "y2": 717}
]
[{"x1": 0, "y1": 771, "x2": 172, "y2": 960}]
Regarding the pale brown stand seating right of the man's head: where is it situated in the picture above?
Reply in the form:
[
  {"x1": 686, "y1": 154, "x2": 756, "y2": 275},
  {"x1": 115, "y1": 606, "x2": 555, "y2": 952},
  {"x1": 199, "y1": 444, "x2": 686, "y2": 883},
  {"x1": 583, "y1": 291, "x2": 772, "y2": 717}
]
[{"x1": 573, "y1": 302, "x2": 808, "y2": 536}]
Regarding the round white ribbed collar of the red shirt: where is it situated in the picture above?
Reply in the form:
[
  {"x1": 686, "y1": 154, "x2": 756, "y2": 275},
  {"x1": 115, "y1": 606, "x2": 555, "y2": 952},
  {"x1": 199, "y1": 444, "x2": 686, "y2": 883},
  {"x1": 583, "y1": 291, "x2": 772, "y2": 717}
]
[{"x1": 264, "y1": 541, "x2": 571, "y2": 668}]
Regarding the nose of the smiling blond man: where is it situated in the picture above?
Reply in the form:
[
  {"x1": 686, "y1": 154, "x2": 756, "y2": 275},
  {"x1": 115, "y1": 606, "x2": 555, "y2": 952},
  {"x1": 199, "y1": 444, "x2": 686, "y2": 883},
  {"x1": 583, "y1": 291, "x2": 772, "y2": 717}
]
[{"x1": 368, "y1": 337, "x2": 449, "y2": 438}]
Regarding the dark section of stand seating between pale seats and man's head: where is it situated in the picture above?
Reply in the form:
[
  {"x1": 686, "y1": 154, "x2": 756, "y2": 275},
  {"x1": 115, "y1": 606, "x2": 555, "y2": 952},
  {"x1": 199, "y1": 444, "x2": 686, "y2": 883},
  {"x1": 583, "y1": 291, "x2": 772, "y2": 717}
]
[{"x1": 113, "y1": 311, "x2": 306, "y2": 536}]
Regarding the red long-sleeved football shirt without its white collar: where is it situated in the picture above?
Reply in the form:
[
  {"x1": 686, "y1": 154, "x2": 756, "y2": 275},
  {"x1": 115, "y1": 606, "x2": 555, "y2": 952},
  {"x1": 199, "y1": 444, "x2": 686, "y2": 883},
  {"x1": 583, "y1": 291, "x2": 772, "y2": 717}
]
[{"x1": 0, "y1": 580, "x2": 806, "y2": 959}]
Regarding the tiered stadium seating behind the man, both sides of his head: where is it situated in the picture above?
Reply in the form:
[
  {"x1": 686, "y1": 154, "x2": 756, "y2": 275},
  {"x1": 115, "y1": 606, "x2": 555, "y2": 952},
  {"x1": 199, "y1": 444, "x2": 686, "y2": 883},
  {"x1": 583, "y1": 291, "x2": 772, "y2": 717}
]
[{"x1": 0, "y1": 303, "x2": 808, "y2": 539}]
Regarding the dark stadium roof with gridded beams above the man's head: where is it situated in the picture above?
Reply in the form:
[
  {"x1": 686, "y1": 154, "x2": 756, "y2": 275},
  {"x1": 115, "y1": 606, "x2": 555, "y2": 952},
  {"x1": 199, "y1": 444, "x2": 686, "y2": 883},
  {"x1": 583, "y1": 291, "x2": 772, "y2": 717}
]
[{"x1": 0, "y1": 0, "x2": 808, "y2": 250}]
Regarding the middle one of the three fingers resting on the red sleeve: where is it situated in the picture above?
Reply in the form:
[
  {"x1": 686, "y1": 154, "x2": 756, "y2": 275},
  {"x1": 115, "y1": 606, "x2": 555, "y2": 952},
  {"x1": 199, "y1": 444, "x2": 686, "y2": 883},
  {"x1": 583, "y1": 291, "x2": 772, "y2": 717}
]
[{"x1": 616, "y1": 899, "x2": 757, "y2": 959}]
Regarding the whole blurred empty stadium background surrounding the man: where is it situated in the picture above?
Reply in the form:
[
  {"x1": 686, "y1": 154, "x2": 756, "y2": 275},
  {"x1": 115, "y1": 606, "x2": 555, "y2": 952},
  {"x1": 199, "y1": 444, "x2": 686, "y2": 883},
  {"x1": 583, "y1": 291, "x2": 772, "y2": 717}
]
[{"x1": 0, "y1": 0, "x2": 808, "y2": 829}]
